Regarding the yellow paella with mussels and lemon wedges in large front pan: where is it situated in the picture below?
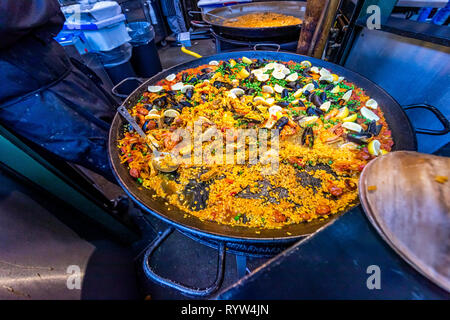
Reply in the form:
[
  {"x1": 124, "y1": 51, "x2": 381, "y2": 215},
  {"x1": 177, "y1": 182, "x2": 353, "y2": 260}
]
[{"x1": 118, "y1": 57, "x2": 394, "y2": 228}]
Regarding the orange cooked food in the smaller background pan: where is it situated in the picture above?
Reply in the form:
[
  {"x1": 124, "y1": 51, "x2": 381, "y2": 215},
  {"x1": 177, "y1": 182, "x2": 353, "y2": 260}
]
[{"x1": 223, "y1": 12, "x2": 302, "y2": 28}]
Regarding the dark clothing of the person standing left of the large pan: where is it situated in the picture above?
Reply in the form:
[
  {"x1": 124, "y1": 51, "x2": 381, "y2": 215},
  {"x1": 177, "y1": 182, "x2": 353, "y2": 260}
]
[{"x1": 0, "y1": 0, "x2": 114, "y2": 177}]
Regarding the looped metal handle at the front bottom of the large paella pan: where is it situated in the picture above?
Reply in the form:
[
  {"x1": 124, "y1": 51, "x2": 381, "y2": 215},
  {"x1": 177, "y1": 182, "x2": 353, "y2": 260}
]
[{"x1": 143, "y1": 227, "x2": 225, "y2": 297}]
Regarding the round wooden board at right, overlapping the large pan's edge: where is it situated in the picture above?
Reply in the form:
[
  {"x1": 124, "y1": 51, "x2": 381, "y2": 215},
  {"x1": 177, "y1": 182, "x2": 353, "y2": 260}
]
[{"x1": 359, "y1": 151, "x2": 450, "y2": 292}]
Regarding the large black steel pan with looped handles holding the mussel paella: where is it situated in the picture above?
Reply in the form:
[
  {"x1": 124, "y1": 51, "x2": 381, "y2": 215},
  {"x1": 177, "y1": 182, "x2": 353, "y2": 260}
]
[{"x1": 108, "y1": 51, "x2": 449, "y2": 296}]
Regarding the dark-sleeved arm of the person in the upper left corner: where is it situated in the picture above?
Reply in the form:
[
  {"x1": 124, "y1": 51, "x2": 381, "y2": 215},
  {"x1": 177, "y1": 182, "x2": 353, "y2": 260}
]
[{"x1": 0, "y1": 0, "x2": 64, "y2": 48}]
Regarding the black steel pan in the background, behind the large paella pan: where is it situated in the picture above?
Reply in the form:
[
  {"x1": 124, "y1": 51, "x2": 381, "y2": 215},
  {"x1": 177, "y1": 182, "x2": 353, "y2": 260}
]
[{"x1": 202, "y1": 1, "x2": 306, "y2": 40}]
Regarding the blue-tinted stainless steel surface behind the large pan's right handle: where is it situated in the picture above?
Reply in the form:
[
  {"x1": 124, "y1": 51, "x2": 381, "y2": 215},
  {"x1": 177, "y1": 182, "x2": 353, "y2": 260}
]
[{"x1": 345, "y1": 29, "x2": 450, "y2": 153}]
